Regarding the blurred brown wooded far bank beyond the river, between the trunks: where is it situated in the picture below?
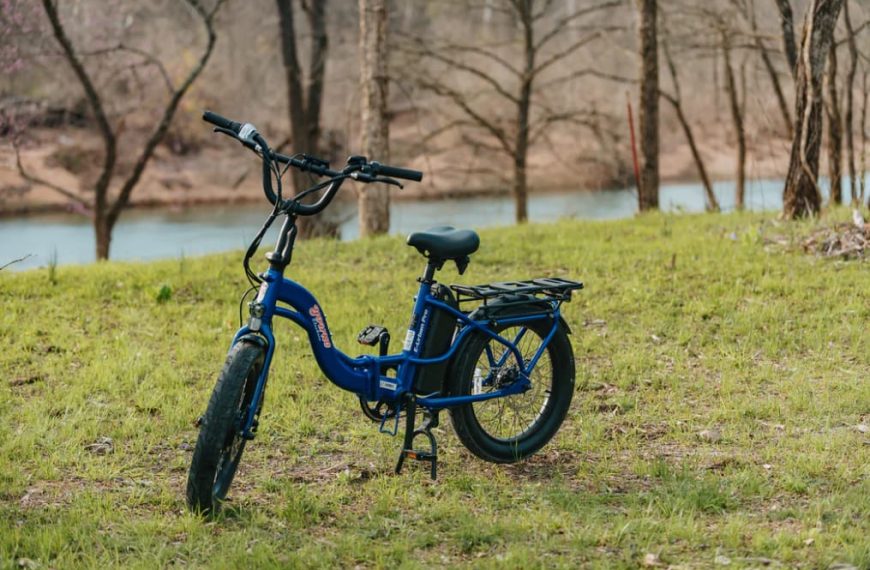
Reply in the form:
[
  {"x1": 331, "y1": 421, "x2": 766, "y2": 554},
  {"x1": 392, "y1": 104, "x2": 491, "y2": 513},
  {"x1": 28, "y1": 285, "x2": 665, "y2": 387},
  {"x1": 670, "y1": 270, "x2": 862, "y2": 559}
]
[{"x1": 0, "y1": 0, "x2": 868, "y2": 212}]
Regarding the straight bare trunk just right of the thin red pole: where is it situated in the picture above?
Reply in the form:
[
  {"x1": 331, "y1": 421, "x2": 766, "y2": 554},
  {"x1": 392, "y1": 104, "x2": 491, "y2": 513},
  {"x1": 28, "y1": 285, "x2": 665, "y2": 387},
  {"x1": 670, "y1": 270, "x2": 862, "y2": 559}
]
[{"x1": 637, "y1": 0, "x2": 659, "y2": 212}]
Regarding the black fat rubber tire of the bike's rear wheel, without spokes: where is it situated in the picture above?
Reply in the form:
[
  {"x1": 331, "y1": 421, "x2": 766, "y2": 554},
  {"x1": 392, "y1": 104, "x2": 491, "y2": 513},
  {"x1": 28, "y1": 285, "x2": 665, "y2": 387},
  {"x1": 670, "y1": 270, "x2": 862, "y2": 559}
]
[{"x1": 447, "y1": 319, "x2": 575, "y2": 463}]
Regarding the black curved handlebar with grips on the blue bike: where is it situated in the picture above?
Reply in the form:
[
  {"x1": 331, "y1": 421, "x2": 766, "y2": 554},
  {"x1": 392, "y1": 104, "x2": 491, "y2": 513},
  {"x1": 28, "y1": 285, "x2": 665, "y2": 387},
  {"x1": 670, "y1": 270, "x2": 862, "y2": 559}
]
[{"x1": 202, "y1": 111, "x2": 423, "y2": 216}]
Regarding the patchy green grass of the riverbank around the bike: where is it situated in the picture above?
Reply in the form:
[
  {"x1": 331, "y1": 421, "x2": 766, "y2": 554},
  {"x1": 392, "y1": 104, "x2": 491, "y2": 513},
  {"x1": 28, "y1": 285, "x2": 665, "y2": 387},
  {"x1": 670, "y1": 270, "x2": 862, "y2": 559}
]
[{"x1": 0, "y1": 211, "x2": 870, "y2": 568}]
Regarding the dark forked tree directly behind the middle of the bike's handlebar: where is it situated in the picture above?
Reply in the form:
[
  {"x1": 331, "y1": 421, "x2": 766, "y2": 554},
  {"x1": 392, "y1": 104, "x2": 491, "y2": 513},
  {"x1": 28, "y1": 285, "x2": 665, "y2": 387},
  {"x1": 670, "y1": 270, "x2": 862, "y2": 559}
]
[{"x1": 275, "y1": 0, "x2": 338, "y2": 237}]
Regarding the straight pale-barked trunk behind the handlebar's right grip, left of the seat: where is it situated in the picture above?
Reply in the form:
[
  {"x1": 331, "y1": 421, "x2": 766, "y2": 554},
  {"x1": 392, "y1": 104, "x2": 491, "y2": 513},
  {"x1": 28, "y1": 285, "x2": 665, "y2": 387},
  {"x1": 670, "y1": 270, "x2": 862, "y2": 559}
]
[{"x1": 359, "y1": 0, "x2": 390, "y2": 237}]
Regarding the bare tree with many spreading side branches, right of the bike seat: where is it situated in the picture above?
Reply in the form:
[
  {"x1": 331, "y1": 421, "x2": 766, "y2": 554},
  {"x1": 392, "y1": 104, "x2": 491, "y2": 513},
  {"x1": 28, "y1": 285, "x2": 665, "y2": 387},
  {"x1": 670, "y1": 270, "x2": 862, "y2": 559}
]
[{"x1": 407, "y1": 0, "x2": 621, "y2": 222}]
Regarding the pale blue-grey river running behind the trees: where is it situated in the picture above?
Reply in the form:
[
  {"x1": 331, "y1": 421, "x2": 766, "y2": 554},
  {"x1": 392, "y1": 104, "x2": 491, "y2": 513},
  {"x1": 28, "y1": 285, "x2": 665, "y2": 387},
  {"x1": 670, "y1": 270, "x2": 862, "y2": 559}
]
[{"x1": 0, "y1": 180, "x2": 844, "y2": 270}]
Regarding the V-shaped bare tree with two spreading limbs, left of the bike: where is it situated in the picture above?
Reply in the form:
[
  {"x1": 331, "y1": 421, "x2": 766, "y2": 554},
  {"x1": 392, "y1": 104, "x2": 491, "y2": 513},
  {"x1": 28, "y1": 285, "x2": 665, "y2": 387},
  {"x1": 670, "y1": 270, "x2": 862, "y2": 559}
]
[{"x1": 17, "y1": 0, "x2": 224, "y2": 259}]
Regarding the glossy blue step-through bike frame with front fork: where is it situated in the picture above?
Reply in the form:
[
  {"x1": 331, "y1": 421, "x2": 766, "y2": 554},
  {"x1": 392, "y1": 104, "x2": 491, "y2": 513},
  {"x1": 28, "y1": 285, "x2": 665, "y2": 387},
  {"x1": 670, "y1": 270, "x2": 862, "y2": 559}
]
[{"x1": 233, "y1": 264, "x2": 560, "y2": 438}]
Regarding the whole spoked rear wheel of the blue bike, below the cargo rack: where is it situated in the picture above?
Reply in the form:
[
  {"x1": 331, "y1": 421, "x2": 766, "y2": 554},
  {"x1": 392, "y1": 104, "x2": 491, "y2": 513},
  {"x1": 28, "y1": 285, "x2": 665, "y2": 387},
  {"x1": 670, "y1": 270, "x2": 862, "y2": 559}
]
[{"x1": 447, "y1": 319, "x2": 574, "y2": 463}]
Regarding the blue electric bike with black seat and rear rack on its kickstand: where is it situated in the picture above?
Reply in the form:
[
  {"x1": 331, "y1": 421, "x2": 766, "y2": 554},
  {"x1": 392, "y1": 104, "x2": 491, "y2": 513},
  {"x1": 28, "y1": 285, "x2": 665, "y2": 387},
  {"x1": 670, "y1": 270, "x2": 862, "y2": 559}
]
[{"x1": 187, "y1": 111, "x2": 583, "y2": 514}]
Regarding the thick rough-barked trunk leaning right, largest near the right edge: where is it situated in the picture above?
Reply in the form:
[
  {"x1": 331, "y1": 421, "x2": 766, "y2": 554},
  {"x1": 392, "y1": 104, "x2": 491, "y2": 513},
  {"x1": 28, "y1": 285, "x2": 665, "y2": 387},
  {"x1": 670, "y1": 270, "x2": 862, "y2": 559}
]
[{"x1": 782, "y1": 0, "x2": 843, "y2": 219}]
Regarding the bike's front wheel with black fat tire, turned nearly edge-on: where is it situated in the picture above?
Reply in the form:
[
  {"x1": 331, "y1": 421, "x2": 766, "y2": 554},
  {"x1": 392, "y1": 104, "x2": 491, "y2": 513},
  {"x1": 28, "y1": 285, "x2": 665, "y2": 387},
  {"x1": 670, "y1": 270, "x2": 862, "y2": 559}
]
[{"x1": 187, "y1": 340, "x2": 265, "y2": 514}]
